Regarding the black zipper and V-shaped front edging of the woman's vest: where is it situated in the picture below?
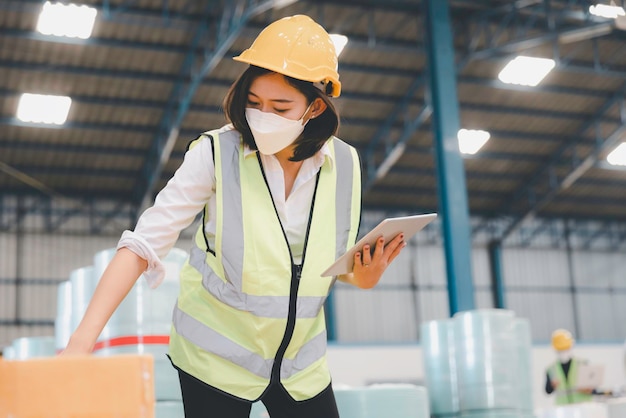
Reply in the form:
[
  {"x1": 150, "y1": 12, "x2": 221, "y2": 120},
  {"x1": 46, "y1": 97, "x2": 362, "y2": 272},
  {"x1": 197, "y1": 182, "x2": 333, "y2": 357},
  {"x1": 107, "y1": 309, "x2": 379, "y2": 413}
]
[{"x1": 257, "y1": 151, "x2": 322, "y2": 384}]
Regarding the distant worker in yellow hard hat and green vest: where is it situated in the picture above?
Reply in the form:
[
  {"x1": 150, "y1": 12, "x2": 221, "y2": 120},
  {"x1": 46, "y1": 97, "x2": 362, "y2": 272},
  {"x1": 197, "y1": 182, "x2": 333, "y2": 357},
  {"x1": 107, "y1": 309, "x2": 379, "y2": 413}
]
[{"x1": 546, "y1": 329, "x2": 594, "y2": 405}]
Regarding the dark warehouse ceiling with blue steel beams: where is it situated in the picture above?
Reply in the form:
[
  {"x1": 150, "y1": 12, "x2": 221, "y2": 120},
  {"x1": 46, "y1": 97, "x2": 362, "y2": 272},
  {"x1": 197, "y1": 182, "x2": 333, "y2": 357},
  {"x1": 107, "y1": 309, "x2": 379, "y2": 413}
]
[{"x1": 0, "y1": 0, "x2": 626, "y2": 240}]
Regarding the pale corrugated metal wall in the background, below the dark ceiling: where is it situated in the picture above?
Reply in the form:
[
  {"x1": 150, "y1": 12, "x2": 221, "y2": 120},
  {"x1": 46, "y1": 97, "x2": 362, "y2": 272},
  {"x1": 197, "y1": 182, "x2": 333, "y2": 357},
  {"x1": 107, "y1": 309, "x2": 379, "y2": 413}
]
[{"x1": 0, "y1": 219, "x2": 626, "y2": 346}]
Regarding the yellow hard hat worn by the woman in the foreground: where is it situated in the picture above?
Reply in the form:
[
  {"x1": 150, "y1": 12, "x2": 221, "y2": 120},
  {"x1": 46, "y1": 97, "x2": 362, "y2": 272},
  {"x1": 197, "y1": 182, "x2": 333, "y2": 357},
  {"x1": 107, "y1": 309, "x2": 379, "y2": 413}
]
[{"x1": 233, "y1": 15, "x2": 341, "y2": 97}]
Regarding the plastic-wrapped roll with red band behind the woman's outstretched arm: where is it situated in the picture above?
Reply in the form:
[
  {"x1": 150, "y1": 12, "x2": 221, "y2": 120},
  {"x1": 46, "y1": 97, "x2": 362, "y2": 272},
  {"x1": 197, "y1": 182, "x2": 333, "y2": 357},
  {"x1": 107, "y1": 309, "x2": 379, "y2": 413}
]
[{"x1": 94, "y1": 248, "x2": 187, "y2": 401}]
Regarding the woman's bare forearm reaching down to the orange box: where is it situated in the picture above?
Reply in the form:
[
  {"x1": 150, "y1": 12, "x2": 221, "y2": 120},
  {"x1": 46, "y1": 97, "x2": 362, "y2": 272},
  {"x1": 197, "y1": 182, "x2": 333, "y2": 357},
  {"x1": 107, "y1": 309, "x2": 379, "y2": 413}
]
[{"x1": 64, "y1": 248, "x2": 148, "y2": 354}]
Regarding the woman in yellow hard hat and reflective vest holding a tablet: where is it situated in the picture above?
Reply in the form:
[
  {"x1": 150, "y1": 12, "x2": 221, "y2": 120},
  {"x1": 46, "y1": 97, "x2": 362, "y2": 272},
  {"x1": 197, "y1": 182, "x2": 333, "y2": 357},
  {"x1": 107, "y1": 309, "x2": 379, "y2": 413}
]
[{"x1": 64, "y1": 15, "x2": 406, "y2": 418}]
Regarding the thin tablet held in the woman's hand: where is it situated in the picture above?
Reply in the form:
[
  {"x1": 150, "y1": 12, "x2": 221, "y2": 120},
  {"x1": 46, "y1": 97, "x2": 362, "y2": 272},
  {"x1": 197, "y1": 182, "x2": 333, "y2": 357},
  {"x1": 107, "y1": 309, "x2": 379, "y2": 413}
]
[{"x1": 322, "y1": 213, "x2": 437, "y2": 277}]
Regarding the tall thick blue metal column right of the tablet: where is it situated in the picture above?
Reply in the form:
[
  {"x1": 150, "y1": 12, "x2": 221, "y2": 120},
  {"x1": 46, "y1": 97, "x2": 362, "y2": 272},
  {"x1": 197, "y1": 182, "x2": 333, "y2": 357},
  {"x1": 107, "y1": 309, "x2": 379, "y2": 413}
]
[{"x1": 424, "y1": 0, "x2": 474, "y2": 315}]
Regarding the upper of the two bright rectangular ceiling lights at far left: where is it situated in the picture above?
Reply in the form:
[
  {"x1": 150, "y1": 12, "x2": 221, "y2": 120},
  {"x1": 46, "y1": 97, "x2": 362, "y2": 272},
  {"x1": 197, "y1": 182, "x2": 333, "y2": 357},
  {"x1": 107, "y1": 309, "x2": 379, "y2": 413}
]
[{"x1": 37, "y1": 1, "x2": 98, "y2": 39}]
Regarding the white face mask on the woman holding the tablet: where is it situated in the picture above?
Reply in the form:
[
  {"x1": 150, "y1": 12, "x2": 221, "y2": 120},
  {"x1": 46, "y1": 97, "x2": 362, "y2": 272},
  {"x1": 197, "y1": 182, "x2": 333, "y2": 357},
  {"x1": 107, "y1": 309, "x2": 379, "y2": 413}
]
[{"x1": 246, "y1": 105, "x2": 311, "y2": 155}]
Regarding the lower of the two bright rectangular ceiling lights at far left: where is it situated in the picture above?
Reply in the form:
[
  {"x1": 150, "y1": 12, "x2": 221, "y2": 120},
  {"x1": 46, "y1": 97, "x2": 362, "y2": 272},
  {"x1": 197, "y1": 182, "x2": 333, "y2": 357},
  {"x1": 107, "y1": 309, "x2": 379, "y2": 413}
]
[{"x1": 17, "y1": 93, "x2": 72, "y2": 125}]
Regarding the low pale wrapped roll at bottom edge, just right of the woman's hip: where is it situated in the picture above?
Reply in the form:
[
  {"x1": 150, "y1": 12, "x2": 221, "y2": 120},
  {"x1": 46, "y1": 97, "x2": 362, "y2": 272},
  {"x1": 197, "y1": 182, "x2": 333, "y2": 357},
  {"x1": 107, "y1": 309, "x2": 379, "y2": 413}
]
[{"x1": 335, "y1": 384, "x2": 430, "y2": 418}]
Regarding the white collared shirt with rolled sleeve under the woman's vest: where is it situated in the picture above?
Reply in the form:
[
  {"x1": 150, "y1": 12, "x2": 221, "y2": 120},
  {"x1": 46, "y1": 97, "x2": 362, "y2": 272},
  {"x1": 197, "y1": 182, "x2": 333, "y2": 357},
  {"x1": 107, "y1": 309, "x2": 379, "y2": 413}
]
[{"x1": 117, "y1": 125, "x2": 333, "y2": 287}]
